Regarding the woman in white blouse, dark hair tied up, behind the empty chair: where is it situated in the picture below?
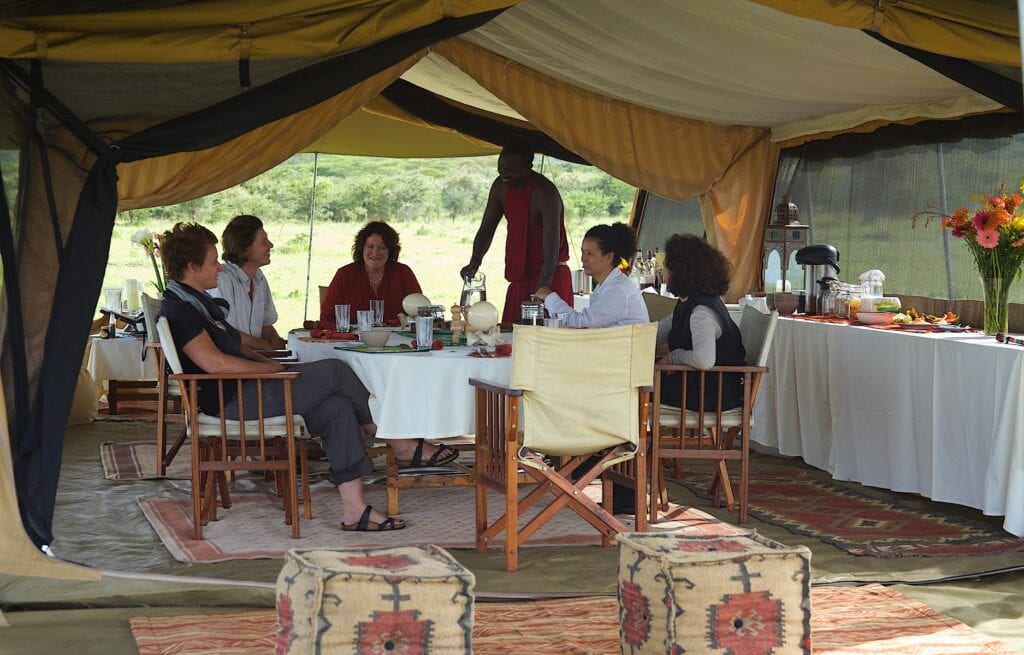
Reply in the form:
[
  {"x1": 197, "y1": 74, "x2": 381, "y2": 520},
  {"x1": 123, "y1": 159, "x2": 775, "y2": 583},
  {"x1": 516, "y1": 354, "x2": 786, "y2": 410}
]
[{"x1": 535, "y1": 223, "x2": 650, "y2": 328}]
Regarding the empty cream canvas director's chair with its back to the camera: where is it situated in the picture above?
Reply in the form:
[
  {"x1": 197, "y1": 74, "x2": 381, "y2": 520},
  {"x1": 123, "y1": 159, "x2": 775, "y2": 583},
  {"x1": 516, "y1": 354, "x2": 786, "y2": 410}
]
[{"x1": 470, "y1": 323, "x2": 657, "y2": 571}]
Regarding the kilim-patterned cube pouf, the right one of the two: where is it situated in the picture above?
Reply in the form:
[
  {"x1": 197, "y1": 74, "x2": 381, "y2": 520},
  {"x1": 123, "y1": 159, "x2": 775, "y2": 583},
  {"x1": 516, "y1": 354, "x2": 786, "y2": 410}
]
[{"x1": 617, "y1": 531, "x2": 811, "y2": 655}]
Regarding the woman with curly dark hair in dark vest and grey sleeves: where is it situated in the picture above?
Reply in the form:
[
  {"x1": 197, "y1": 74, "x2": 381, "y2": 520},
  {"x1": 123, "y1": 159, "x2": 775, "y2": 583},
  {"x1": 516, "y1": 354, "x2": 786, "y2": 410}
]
[{"x1": 657, "y1": 234, "x2": 745, "y2": 409}]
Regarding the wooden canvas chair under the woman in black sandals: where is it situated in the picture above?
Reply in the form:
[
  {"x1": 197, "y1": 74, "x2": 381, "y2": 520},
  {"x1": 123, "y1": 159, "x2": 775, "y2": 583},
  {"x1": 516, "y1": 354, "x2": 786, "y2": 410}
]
[{"x1": 157, "y1": 317, "x2": 311, "y2": 539}]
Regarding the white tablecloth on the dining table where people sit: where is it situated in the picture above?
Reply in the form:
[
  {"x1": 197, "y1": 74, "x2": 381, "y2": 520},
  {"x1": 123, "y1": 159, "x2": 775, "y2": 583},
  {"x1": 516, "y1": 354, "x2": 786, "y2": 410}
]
[{"x1": 288, "y1": 334, "x2": 512, "y2": 439}]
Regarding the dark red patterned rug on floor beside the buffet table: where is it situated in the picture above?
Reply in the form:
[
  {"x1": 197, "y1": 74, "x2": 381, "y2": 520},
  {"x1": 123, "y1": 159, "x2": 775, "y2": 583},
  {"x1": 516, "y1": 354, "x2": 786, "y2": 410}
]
[{"x1": 679, "y1": 467, "x2": 1024, "y2": 558}]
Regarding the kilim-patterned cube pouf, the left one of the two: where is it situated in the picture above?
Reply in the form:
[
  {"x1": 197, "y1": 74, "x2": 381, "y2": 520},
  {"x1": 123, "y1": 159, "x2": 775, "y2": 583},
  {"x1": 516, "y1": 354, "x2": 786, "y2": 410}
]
[{"x1": 276, "y1": 545, "x2": 476, "y2": 655}]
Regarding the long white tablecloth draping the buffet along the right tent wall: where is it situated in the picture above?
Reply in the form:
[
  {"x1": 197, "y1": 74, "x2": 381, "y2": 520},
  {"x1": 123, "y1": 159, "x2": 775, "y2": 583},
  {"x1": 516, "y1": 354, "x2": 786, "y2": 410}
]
[{"x1": 753, "y1": 318, "x2": 1024, "y2": 536}]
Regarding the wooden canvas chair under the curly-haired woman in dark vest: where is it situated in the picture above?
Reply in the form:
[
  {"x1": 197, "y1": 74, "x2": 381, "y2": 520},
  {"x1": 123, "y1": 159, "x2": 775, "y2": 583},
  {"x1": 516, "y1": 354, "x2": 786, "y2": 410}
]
[{"x1": 650, "y1": 305, "x2": 778, "y2": 523}]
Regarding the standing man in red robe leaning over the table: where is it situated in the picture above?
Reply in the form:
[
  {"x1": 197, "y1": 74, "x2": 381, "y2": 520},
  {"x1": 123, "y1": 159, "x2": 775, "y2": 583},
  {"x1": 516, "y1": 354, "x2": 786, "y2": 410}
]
[{"x1": 462, "y1": 140, "x2": 572, "y2": 323}]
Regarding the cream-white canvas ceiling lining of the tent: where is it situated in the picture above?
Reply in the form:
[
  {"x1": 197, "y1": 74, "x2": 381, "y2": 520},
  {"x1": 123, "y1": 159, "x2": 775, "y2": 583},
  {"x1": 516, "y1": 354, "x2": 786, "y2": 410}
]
[{"x1": 403, "y1": 0, "x2": 1000, "y2": 140}]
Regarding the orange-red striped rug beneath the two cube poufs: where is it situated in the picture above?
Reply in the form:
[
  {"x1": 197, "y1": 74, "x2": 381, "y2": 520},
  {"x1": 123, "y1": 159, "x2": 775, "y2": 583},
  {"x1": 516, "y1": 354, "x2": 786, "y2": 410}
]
[{"x1": 129, "y1": 584, "x2": 1014, "y2": 655}]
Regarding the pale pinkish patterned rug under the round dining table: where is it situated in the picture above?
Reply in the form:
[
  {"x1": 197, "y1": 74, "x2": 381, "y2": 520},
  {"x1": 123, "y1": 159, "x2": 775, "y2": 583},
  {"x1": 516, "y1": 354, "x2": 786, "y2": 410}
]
[{"x1": 138, "y1": 486, "x2": 741, "y2": 563}]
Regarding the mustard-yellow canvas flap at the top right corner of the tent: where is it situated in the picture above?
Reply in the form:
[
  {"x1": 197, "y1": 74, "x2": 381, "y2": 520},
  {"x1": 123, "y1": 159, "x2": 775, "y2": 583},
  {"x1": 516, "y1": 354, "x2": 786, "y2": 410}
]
[{"x1": 753, "y1": 0, "x2": 1021, "y2": 69}]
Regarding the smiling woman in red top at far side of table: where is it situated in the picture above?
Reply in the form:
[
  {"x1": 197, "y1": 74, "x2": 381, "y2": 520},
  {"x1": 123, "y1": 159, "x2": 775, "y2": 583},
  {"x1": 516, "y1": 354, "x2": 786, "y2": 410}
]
[{"x1": 321, "y1": 221, "x2": 423, "y2": 328}]
